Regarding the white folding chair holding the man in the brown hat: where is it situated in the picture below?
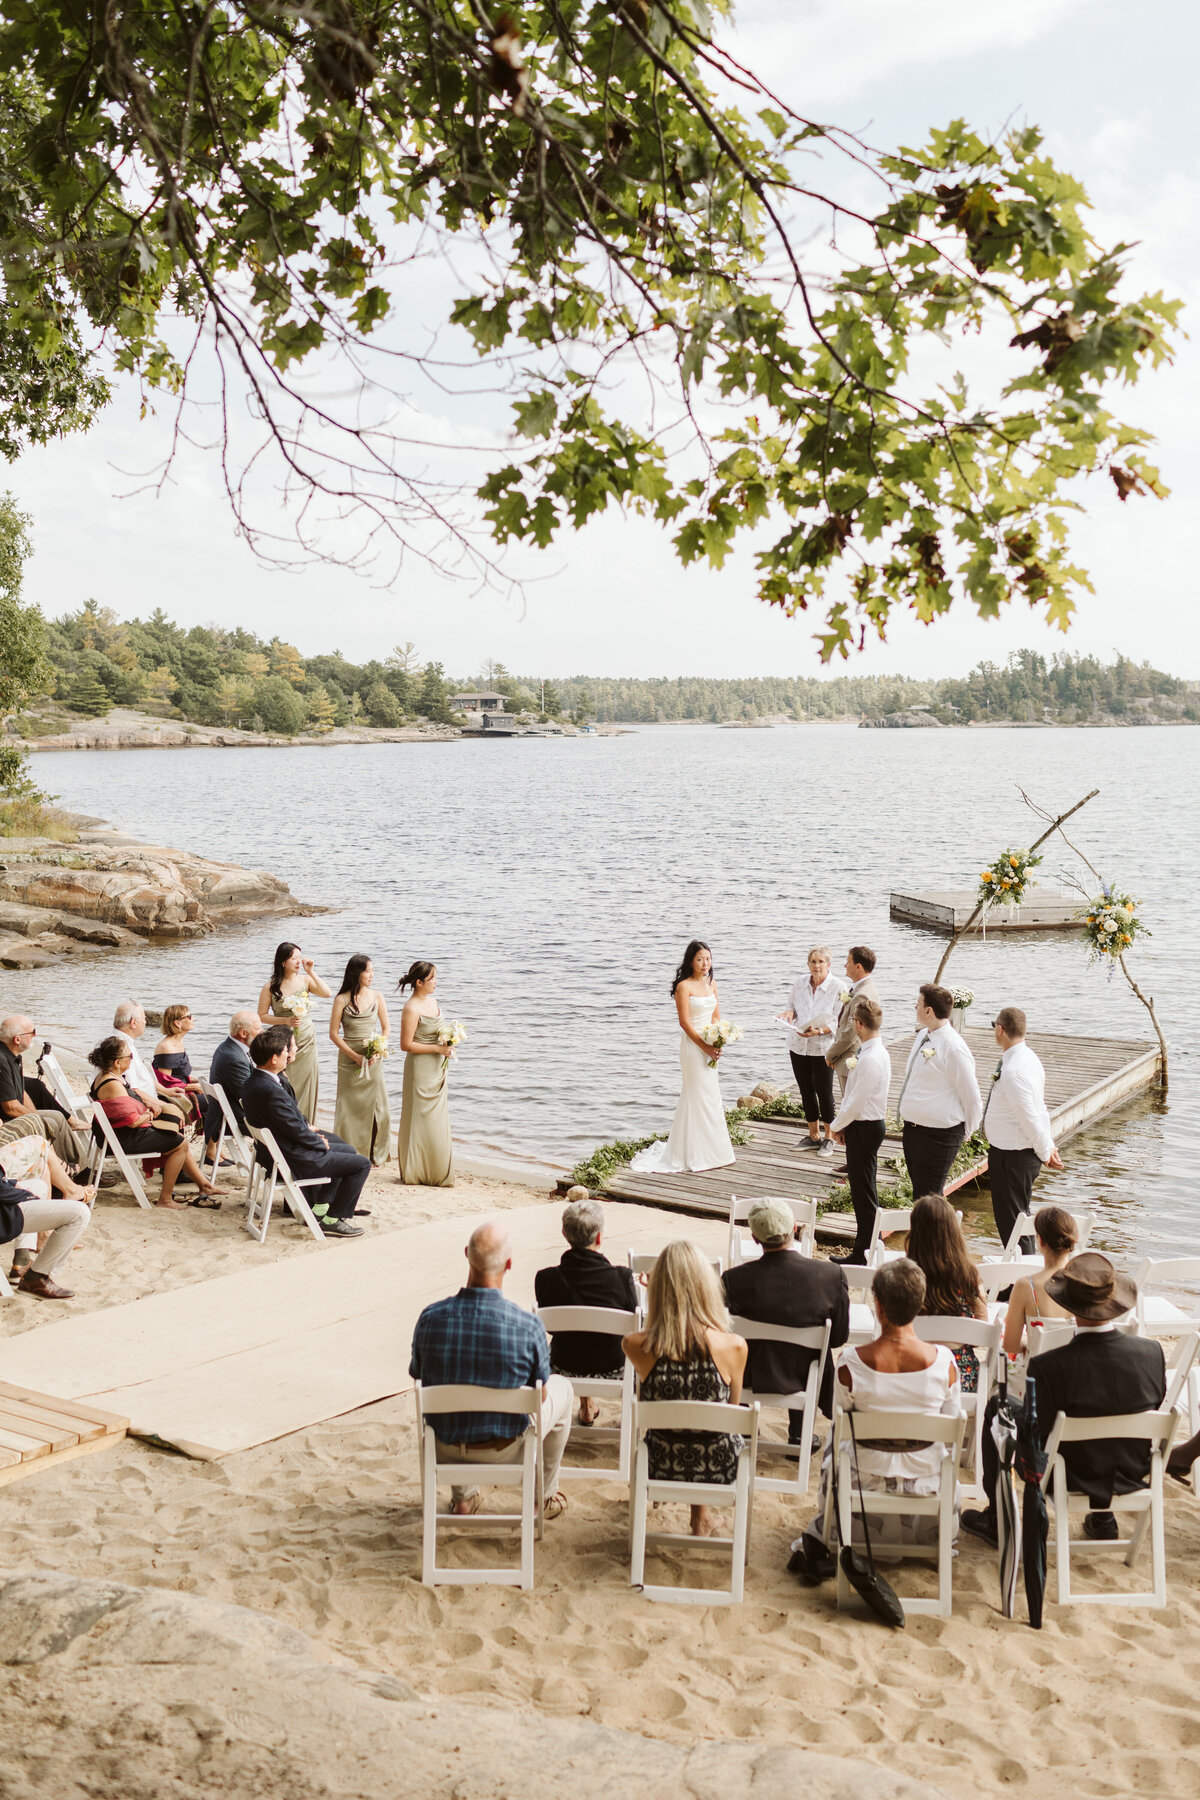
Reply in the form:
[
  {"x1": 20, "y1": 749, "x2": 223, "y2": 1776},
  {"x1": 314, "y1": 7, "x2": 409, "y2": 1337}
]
[{"x1": 1042, "y1": 1411, "x2": 1178, "y2": 1606}]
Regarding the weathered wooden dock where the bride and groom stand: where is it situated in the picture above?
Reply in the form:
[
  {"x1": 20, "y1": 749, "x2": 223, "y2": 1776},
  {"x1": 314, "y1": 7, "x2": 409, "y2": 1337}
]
[{"x1": 604, "y1": 1026, "x2": 1159, "y2": 1224}]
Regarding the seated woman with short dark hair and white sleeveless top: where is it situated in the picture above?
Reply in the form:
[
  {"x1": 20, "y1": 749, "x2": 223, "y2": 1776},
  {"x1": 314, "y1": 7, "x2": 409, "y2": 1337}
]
[{"x1": 788, "y1": 1256, "x2": 961, "y2": 1584}]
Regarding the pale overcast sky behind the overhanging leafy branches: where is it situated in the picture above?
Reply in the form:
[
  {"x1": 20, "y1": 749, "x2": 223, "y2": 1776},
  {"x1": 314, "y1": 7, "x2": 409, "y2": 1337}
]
[{"x1": 11, "y1": 0, "x2": 1200, "y2": 677}]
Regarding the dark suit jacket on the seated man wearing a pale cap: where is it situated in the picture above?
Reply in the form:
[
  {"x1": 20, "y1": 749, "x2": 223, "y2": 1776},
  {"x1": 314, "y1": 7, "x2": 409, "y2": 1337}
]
[{"x1": 721, "y1": 1249, "x2": 849, "y2": 1418}]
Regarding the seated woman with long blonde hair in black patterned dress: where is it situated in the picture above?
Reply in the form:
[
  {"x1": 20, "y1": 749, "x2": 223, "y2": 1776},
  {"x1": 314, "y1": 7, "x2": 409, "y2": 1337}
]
[{"x1": 621, "y1": 1238, "x2": 747, "y2": 1537}]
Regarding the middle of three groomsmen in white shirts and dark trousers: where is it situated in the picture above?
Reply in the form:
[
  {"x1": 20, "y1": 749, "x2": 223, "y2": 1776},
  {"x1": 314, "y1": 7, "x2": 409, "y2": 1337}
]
[{"x1": 896, "y1": 981, "x2": 984, "y2": 1201}]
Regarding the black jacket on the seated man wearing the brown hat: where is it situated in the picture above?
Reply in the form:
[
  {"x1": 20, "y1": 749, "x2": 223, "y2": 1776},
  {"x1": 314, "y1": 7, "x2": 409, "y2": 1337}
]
[{"x1": 1025, "y1": 1327, "x2": 1166, "y2": 1508}]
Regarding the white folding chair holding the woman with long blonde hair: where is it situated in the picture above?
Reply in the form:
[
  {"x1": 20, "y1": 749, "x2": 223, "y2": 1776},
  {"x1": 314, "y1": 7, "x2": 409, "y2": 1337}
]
[{"x1": 630, "y1": 1400, "x2": 759, "y2": 1606}]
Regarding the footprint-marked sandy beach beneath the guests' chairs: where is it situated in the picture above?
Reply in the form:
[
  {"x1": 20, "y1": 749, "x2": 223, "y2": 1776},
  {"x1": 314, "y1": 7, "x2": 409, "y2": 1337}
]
[{"x1": 0, "y1": 1172, "x2": 1200, "y2": 1800}]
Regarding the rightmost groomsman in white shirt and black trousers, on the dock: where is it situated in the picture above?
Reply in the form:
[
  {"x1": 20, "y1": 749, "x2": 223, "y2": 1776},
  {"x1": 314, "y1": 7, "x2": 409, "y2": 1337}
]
[{"x1": 984, "y1": 1006, "x2": 1063, "y2": 1256}]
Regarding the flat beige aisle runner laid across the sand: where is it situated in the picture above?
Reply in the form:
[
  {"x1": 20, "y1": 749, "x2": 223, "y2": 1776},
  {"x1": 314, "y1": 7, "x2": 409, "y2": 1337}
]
[{"x1": 0, "y1": 1202, "x2": 725, "y2": 1460}]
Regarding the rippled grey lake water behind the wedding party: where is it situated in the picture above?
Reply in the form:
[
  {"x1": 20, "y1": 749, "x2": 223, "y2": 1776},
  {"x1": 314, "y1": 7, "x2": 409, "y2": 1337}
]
[{"x1": 11, "y1": 725, "x2": 1200, "y2": 1256}]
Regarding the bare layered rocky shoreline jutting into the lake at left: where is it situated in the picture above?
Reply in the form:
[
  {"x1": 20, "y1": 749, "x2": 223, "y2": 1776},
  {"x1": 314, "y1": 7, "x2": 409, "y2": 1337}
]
[{"x1": 0, "y1": 814, "x2": 326, "y2": 968}]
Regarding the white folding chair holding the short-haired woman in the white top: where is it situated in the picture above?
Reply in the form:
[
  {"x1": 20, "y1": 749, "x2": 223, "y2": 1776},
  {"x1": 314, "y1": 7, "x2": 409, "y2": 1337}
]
[{"x1": 826, "y1": 1382, "x2": 966, "y2": 1618}]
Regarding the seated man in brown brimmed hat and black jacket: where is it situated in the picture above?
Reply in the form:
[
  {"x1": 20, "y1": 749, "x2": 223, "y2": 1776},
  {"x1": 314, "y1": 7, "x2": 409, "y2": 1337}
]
[{"x1": 963, "y1": 1251, "x2": 1166, "y2": 1543}]
